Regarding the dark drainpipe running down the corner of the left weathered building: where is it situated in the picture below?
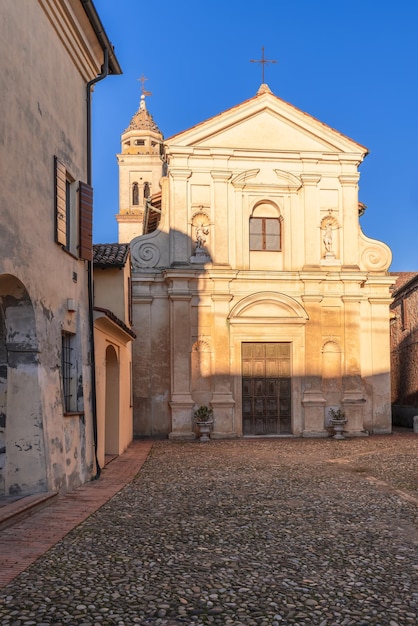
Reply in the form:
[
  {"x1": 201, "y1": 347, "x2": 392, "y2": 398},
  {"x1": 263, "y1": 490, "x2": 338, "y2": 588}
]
[{"x1": 87, "y1": 48, "x2": 109, "y2": 480}]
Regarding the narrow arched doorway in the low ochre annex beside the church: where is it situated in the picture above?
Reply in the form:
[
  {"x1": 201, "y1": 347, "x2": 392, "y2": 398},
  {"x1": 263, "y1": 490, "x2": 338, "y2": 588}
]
[{"x1": 105, "y1": 346, "x2": 119, "y2": 454}]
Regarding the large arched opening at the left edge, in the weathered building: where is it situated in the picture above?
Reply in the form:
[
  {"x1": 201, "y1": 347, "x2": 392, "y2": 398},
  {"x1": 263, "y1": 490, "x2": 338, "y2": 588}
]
[{"x1": 0, "y1": 274, "x2": 47, "y2": 496}]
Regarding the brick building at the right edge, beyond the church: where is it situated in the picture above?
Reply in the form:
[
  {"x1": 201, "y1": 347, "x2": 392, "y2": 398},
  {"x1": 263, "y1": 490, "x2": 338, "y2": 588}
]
[{"x1": 390, "y1": 272, "x2": 418, "y2": 428}]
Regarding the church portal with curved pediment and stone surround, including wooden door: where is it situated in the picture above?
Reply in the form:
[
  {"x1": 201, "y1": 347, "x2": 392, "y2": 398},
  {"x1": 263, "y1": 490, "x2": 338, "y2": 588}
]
[{"x1": 228, "y1": 291, "x2": 308, "y2": 436}]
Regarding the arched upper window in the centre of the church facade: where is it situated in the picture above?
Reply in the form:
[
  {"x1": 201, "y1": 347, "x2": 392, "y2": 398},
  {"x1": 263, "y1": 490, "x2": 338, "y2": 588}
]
[{"x1": 250, "y1": 202, "x2": 282, "y2": 251}]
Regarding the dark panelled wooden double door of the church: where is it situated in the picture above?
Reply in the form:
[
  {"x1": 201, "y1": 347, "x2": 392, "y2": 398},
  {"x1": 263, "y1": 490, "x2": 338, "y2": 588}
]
[{"x1": 241, "y1": 343, "x2": 292, "y2": 436}]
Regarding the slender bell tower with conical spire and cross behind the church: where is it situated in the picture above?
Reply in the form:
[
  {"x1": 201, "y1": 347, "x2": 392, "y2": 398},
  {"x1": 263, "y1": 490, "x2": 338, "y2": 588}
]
[{"x1": 116, "y1": 76, "x2": 164, "y2": 243}]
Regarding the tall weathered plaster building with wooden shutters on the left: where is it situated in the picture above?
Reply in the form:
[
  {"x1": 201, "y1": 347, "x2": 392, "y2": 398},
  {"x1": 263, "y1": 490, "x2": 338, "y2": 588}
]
[{"x1": 0, "y1": 0, "x2": 121, "y2": 496}]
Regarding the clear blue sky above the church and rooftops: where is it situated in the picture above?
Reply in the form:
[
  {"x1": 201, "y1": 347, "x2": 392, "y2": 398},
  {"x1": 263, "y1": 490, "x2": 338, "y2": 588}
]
[{"x1": 93, "y1": 0, "x2": 418, "y2": 272}]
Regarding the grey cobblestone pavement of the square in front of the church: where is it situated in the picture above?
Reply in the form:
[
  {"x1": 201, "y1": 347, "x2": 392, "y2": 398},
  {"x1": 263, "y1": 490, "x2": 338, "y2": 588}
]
[{"x1": 0, "y1": 434, "x2": 418, "y2": 626}]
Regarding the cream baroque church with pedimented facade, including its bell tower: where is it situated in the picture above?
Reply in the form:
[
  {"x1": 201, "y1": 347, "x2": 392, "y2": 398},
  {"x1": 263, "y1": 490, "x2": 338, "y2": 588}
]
[{"x1": 117, "y1": 83, "x2": 394, "y2": 440}]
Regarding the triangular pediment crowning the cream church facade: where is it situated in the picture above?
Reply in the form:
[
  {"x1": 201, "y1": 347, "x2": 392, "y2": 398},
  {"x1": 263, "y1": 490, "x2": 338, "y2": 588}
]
[{"x1": 167, "y1": 92, "x2": 367, "y2": 155}]
